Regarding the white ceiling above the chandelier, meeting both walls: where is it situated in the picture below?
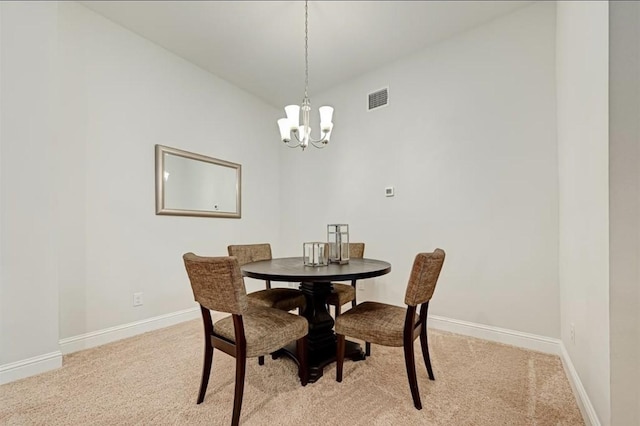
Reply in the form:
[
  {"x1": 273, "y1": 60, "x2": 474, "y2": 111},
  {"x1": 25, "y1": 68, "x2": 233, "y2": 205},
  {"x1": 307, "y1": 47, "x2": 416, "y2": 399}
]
[{"x1": 80, "y1": 1, "x2": 532, "y2": 107}]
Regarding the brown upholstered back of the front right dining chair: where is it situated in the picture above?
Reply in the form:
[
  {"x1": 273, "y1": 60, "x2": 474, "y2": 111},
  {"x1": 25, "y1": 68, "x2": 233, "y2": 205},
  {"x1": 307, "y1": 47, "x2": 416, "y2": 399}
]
[{"x1": 404, "y1": 249, "x2": 444, "y2": 306}]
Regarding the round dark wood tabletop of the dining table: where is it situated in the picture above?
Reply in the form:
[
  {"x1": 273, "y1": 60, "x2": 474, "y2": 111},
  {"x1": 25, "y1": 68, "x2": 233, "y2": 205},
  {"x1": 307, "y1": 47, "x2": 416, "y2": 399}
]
[{"x1": 241, "y1": 257, "x2": 391, "y2": 282}]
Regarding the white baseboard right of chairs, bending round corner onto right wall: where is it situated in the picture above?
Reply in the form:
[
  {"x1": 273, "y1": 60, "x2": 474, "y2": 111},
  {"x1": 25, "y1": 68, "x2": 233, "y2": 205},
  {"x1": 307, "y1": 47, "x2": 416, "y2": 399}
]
[{"x1": 427, "y1": 315, "x2": 601, "y2": 426}]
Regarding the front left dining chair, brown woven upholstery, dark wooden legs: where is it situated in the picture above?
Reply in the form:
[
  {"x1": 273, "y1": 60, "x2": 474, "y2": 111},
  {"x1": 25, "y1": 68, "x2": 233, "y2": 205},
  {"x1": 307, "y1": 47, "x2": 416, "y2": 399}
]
[{"x1": 182, "y1": 253, "x2": 309, "y2": 426}]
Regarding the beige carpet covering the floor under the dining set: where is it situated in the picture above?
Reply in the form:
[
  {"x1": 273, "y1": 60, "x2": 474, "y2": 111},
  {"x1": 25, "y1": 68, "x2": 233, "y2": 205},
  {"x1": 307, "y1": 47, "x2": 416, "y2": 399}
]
[{"x1": 0, "y1": 320, "x2": 584, "y2": 426}]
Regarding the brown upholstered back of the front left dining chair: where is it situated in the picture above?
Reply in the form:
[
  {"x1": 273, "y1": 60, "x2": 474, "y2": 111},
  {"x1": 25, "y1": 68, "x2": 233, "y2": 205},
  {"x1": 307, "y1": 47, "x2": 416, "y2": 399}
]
[{"x1": 182, "y1": 253, "x2": 247, "y2": 315}]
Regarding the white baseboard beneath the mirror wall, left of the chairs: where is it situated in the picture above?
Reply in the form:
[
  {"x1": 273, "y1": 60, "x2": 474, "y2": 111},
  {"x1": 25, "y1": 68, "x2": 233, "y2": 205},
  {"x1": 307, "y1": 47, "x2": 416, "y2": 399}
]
[{"x1": 59, "y1": 307, "x2": 200, "y2": 355}]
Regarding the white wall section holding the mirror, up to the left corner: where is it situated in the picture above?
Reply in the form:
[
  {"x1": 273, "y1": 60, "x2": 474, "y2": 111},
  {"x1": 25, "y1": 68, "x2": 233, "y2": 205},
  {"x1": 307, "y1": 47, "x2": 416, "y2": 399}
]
[{"x1": 56, "y1": 2, "x2": 279, "y2": 338}]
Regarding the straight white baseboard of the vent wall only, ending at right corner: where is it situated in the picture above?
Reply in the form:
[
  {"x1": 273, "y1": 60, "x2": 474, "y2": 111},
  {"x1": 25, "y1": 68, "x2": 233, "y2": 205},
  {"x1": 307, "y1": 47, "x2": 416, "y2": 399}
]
[{"x1": 428, "y1": 315, "x2": 561, "y2": 355}]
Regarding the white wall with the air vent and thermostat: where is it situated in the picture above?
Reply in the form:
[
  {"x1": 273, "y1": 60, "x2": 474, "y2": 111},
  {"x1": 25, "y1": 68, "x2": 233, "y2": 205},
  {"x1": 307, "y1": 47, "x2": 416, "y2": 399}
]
[{"x1": 281, "y1": 3, "x2": 560, "y2": 337}]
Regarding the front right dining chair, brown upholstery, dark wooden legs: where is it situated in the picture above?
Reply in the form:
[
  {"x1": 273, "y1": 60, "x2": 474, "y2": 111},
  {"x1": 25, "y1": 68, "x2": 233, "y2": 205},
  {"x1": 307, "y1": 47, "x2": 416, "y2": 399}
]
[{"x1": 335, "y1": 249, "x2": 445, "y2": 410}]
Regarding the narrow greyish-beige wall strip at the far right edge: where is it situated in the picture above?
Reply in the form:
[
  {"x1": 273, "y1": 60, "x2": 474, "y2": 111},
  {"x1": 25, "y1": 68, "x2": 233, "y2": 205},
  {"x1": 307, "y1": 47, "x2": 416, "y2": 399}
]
[{"x1": 609, "y1": 2, "x2": 640, "y2": 425}]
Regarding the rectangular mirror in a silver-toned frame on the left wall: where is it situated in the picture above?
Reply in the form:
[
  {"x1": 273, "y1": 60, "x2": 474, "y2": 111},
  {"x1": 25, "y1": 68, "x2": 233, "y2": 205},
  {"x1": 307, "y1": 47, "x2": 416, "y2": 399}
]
[{"x1": 156, "y1": 145, "x2": 242, "y2": 218}]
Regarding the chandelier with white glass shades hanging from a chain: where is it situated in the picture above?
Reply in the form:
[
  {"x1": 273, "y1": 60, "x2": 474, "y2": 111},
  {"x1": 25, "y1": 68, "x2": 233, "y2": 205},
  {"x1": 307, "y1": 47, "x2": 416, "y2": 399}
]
[{"x1": 278, "y1": 0, "x2": 333, "y2": 151}]
